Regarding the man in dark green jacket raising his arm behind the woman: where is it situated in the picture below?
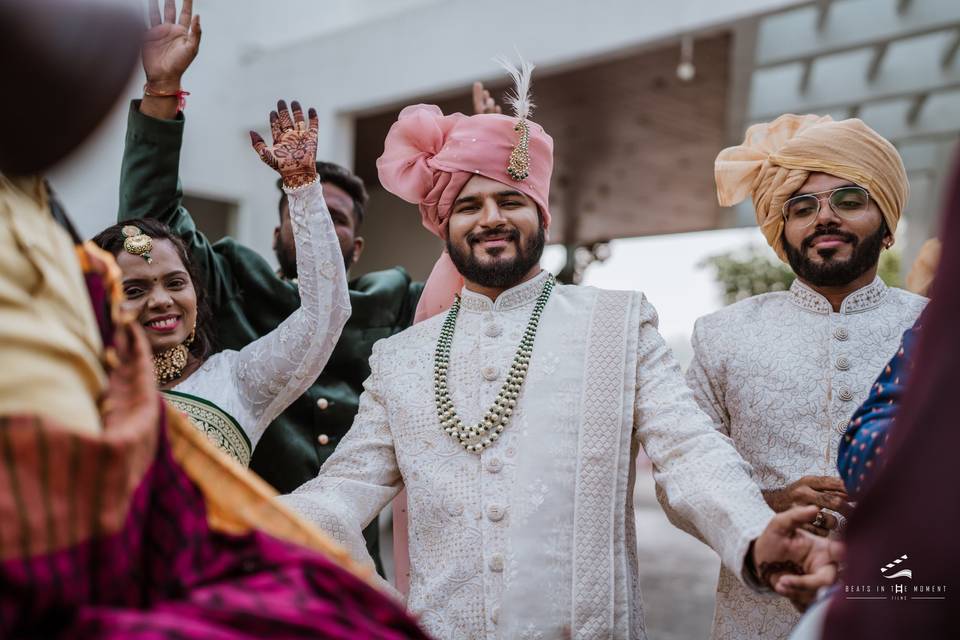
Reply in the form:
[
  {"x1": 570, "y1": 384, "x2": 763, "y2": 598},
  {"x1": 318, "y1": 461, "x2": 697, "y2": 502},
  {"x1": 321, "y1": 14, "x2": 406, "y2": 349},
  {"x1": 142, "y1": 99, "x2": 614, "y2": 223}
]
[{"x1": 118, "y1": 8, "x2": 423, "y2": 573}]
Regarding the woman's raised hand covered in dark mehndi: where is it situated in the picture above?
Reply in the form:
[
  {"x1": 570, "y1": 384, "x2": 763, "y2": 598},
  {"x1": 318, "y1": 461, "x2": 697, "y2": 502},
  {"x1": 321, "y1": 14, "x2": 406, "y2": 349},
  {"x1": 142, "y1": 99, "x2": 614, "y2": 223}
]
[{"x1": 250, "y1": 100, "x2": 319, "y2": 189}]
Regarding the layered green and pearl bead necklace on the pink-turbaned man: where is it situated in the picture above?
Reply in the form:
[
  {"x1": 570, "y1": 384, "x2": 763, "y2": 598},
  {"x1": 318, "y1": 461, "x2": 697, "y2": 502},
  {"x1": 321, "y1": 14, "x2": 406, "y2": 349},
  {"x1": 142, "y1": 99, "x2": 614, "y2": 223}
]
[{"x1": 433, "y1": 276, "x2": 556, "y2": 453}]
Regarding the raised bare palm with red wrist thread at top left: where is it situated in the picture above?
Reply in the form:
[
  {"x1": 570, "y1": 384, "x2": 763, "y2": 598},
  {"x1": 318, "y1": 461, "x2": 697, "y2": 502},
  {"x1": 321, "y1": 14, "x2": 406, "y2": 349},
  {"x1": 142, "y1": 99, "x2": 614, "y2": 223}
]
[{"x1": 141, "y1": 0, "x2": 201, "y2": 94}]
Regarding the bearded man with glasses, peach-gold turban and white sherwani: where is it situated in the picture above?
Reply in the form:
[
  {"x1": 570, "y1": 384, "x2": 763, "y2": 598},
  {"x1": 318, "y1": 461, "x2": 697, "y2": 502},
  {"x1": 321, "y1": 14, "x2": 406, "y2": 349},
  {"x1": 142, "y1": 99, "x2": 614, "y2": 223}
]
[{"x1": 668, "y1": 115, "x2": 926, "y2": 639}]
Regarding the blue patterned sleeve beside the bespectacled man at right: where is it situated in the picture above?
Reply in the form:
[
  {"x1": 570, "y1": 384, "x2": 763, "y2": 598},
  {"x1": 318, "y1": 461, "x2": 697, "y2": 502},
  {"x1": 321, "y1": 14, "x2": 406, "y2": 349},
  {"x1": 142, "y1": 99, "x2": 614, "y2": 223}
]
[{"x1": 837, "y1": 316, "x2": 922, "y2": 499}]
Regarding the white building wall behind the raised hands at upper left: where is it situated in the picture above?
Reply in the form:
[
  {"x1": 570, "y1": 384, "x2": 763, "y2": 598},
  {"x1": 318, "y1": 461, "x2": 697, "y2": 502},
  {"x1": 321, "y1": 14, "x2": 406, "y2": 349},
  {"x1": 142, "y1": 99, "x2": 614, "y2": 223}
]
[{"x1": 51, "y1": 0, "x2": 797, "y2": 262}]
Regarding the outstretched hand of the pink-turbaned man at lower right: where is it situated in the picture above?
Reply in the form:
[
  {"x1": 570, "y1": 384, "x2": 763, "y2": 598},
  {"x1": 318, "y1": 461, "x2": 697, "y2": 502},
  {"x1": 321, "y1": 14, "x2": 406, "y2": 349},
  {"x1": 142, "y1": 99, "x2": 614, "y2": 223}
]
[{"x1": 753, "y1": 506, "x2": 844, "y2": 611}]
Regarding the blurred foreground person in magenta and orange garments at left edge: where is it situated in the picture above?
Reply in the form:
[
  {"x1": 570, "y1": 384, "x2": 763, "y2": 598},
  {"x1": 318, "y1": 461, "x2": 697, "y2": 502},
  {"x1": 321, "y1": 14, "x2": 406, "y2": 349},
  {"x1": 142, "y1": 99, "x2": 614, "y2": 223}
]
[{"x1": 0, "y1": 0, "x2": 424, "y2": 640}]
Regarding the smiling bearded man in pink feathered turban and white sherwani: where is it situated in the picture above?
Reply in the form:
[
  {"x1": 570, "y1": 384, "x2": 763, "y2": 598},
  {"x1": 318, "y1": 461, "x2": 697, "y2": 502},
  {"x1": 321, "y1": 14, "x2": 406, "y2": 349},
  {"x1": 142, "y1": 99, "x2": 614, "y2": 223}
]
[{"x1": 284, "y1": 65, "x2": 835, "y2": 639}]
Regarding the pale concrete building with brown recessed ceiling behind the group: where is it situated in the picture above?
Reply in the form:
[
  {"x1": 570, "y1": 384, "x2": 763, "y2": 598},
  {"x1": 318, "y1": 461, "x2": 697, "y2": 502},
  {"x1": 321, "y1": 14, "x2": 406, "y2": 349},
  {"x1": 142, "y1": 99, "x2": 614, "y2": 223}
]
[{"x1": 52, "y1": 0, "x2": 960, "y2": 277}]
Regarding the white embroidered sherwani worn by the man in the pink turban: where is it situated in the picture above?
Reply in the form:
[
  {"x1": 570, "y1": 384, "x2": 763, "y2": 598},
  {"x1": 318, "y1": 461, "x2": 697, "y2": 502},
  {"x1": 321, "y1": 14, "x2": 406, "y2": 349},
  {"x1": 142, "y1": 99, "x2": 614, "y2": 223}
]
[{"x1": 285, "y1": 273, "x2": 772, "y2": 639}]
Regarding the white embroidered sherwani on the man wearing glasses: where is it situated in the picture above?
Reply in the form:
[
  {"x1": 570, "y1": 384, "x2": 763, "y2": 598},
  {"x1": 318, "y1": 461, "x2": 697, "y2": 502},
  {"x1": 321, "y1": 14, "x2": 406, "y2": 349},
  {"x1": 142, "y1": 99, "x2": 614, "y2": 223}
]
[{"x1": 668, "y1": 278, "x2": 926, "y2": 640}]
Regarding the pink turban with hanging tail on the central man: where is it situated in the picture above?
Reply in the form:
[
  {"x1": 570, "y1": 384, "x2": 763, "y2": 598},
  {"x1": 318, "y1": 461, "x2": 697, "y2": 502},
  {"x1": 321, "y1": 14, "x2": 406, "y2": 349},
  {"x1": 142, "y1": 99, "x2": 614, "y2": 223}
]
[{"x1": 377, "y1": 104, "x2": 553, "y2": 321}]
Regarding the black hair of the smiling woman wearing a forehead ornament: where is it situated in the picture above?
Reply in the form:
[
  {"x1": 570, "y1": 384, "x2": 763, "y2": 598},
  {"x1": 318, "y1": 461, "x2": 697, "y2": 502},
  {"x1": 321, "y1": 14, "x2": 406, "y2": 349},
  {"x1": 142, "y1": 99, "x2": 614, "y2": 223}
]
[{"x1": 93, "y1": 218, "x2": 214, "y2": 362}]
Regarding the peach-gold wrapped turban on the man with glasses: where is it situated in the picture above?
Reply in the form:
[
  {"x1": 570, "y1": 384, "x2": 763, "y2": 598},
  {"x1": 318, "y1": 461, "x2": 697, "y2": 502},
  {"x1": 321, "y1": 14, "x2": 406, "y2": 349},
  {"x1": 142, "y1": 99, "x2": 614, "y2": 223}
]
[{"x1": 714, "y1": 114, "x2": 910, "y2": 262}]
